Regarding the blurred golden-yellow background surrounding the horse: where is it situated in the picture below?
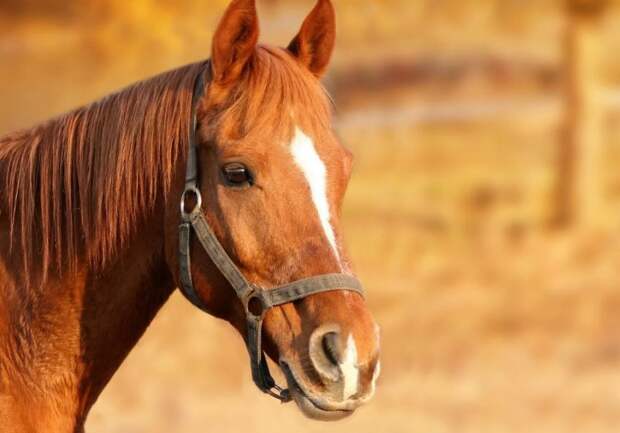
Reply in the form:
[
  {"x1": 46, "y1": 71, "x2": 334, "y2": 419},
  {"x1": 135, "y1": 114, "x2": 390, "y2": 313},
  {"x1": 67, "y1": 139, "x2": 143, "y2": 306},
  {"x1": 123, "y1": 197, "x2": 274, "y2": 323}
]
[{"x1": 0, "y1": 0, "x2": 620, "y2": 433}]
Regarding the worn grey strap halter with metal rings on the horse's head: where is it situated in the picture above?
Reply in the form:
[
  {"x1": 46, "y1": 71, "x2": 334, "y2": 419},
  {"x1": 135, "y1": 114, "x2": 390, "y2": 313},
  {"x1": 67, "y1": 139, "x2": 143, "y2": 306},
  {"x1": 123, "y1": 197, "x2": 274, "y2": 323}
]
[{"x1": 179, "y1": 63, "x2": 364, "y2": 403}]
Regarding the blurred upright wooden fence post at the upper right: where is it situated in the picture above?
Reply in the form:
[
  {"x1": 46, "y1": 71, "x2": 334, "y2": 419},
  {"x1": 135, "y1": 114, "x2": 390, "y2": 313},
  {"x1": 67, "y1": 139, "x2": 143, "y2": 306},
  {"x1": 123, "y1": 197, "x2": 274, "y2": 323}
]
[{"x1": 555, "y1": 0, "x2": 608, "y2": 227}]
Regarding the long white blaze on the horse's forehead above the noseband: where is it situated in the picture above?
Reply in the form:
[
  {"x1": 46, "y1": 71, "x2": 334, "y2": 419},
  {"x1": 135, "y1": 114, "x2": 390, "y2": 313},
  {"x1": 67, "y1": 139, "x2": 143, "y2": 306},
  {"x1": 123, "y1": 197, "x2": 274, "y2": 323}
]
[{"x1": 291, "y1": 128, "x2": 340, "y2": 263}]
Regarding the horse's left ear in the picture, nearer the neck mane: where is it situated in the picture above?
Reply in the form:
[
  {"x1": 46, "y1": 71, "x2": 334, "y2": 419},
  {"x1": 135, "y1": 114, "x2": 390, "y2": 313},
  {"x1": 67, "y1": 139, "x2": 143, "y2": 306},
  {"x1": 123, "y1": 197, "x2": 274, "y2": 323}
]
[{"x1": 211, "y1": 0, "x2": 259, "y2": 84}]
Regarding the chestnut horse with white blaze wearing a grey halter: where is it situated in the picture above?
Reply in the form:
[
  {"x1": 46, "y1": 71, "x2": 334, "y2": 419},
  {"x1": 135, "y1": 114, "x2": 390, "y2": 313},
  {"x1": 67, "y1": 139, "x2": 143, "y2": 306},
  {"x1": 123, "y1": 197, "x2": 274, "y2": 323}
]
[{"x1": 0, "y1": 0, "x2": 380, "y2": 433}]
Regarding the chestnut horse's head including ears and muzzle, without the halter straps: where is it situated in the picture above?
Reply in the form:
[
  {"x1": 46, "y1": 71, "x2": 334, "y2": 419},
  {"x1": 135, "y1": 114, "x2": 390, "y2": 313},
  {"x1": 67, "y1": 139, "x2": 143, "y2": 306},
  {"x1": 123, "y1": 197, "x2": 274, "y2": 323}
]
[{"x1": 185, "y1": 0, "x2": 379, "y2": 419}]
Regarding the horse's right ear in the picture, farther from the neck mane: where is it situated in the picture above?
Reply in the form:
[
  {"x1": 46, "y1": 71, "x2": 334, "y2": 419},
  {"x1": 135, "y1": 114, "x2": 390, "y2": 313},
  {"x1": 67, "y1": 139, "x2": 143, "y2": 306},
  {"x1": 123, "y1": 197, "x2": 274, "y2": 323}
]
[{"x1": 288, "y1": 0, "x2": 336, "y2": 78}]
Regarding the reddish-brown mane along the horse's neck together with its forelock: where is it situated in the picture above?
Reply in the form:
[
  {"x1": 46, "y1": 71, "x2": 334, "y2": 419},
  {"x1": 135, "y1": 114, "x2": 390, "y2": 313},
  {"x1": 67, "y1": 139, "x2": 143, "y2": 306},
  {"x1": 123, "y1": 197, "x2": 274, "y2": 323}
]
[{"x1": 0, "y1": 46, "x2": 331, "y2": 282}]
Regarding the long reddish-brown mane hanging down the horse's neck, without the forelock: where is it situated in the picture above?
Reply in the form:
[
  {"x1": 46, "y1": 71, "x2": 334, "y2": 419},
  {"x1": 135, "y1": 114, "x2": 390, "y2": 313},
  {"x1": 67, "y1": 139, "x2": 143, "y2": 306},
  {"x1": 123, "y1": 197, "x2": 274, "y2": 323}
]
[{"x1": 0, "y1": 64, "x2": 204, "y2": 280}]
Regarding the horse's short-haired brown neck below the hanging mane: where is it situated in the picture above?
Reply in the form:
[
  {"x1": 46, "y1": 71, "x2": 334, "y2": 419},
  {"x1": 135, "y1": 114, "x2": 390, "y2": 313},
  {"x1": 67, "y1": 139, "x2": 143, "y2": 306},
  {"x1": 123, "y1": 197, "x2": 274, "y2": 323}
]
[{"x1": 0, "y1": 202, "x2": 174, "y2": 432}]
